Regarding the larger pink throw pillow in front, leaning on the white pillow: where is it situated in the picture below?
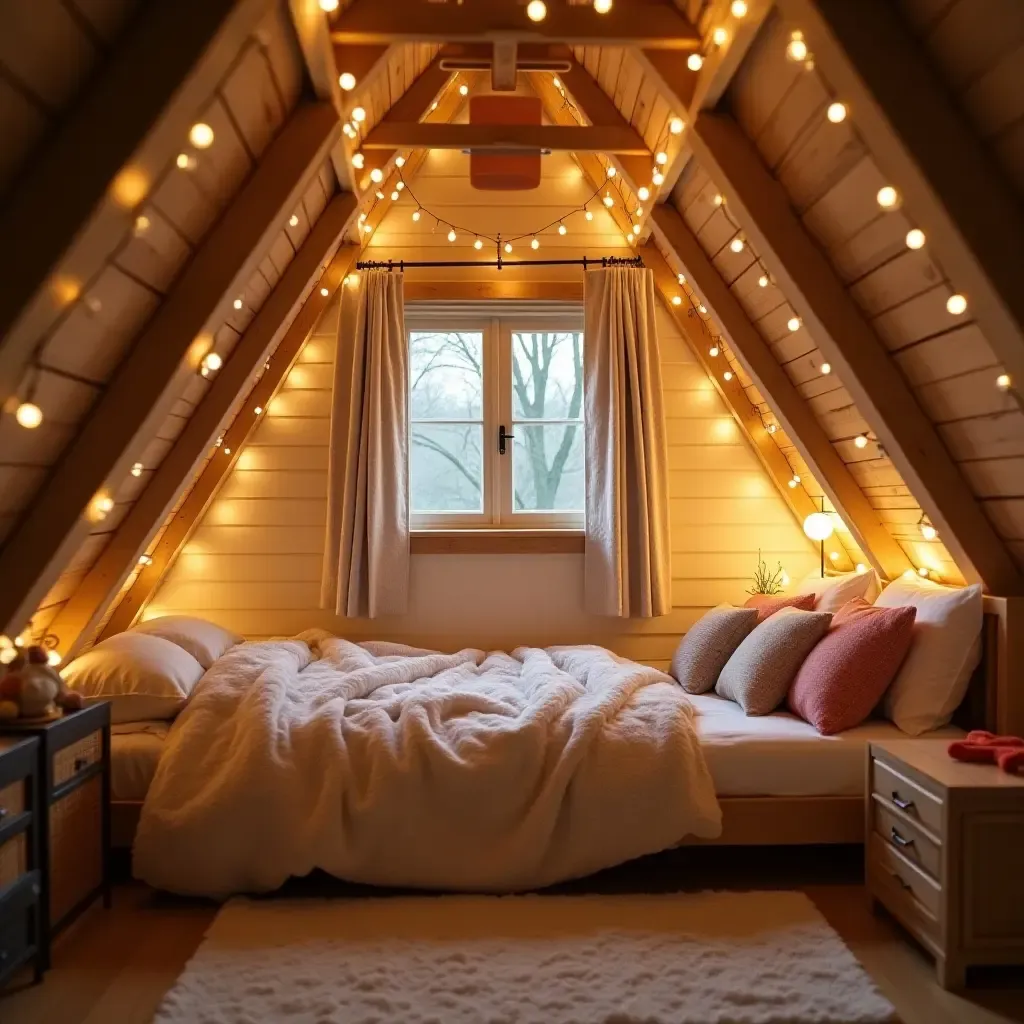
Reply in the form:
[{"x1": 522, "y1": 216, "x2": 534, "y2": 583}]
[{"x1": 788, "y1": 597, "x2": 918, "y2": 736}]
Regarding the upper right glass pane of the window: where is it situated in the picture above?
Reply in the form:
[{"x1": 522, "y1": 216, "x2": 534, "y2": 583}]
[{"x1": 512, "y1": 331, "x2": 583, "y2": 420}]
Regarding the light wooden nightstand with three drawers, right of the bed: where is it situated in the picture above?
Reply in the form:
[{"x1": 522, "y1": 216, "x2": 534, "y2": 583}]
[{"x1": 865, "y1": 739, "x2": 1024, "y2": 988}]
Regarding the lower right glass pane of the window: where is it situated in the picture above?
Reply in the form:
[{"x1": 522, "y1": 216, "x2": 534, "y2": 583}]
[{"x1": 512, "y1": 423, "x2": 585, "y2": 512}]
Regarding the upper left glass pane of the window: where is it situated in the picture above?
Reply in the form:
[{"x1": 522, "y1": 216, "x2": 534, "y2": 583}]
[{"x1": 409, "y1": 331, "x2": 483, "y2": 420}]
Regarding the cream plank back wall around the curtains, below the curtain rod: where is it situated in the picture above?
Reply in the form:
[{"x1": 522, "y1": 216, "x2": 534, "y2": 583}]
[{"x1": 144, "y1": 292, "x2": 816, "y2": 667}]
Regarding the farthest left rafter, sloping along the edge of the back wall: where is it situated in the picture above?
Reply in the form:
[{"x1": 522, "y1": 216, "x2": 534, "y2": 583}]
[{"x1": 96, "y1": 241, "x2": 358, "y2": 640}]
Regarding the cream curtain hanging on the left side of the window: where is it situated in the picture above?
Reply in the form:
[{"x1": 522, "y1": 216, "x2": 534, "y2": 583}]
[{"x1": 321, "y1": 270, "x2": 410, "y2": 617}]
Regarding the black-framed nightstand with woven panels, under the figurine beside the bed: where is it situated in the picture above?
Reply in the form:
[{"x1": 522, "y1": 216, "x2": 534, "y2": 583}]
[{"x1": 4, "y1": 701, "x2": 111, "y2": 968}]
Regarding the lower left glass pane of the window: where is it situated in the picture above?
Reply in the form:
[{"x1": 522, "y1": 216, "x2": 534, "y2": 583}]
[{"x1": 409, "y1": 423, "x2": 483, "y2": 512}]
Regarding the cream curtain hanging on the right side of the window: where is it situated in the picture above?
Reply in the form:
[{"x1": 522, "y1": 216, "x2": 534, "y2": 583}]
[{"x1": 584, "y1": 267, "x2": 672, "y2": 618}]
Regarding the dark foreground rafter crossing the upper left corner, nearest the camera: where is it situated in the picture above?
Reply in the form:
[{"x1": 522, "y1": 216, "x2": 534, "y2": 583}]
[{"x1": 0, "y1": 0, "x2": 270, "y2": 403}]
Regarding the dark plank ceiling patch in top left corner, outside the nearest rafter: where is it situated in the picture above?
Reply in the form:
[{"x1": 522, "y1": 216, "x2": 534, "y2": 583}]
[{"x1": 0, "y1": 0, "x2": 138, "y2": 197}]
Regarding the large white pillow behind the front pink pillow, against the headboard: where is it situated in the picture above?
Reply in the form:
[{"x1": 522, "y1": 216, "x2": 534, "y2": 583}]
[{"x1": 874, "y1": 577, "x2": 982, "y2": 736}]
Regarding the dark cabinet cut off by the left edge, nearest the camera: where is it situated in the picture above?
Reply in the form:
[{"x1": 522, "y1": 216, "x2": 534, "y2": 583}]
[{"x1": 0, "y1": 736, "x2": 45, "y2": 985}]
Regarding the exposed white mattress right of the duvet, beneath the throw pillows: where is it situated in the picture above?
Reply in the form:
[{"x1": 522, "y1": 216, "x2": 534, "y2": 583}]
[{"x1": 691, "y1": 693, "x2": 963, "y2": 797}]
